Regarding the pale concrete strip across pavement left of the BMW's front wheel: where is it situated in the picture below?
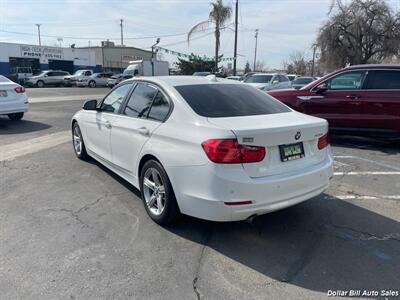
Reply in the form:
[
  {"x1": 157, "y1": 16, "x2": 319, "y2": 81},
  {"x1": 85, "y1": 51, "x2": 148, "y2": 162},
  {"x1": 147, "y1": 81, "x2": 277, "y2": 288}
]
[{"x1": 0, "y1": 130, "x2": 71, "y2": 161}]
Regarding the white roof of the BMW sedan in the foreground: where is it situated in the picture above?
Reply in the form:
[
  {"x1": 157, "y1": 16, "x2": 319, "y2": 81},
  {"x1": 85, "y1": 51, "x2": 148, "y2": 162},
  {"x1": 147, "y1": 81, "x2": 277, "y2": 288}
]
[{"x1": 125, "y1": 75, "x2": 242, "y2": 86}]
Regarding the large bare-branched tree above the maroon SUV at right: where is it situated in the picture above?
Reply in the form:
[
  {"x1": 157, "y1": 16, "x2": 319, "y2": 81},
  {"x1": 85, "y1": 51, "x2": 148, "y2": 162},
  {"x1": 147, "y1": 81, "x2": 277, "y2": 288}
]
[{"x1": 317, "y1": 0, "x2": 400, "y2": 69}]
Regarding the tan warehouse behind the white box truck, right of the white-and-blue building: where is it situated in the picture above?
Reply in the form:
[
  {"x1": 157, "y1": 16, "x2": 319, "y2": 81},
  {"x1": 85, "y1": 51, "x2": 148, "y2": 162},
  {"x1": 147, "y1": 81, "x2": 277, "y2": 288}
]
[{"x1": 79, "y1": 41, "x2": 151, "y2": 73}]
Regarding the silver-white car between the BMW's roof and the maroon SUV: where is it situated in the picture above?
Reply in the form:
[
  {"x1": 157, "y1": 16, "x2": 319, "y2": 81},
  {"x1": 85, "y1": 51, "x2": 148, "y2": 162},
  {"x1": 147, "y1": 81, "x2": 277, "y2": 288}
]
[{"x1": 243, "y1": 73, "x2": 291, "y2": 91}]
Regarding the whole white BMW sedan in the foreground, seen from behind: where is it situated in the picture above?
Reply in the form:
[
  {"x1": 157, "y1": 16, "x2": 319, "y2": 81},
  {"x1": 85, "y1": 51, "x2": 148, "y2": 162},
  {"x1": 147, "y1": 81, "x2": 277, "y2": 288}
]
[{"x1": 72, "y1": 76, "x2": 333, "y2": 224}]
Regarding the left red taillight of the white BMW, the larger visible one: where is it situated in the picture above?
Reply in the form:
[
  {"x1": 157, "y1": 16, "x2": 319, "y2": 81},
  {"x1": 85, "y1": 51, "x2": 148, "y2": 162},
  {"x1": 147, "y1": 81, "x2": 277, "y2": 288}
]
[{"x1": 201, "y1": 139, "x2": 265, "y2": 164}]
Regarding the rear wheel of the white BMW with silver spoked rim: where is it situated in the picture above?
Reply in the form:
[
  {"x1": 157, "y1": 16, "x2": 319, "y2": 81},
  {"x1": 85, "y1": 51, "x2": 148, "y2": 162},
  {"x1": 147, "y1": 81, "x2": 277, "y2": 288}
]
[{"x1": 140, "y1": 160, "x2": 180, "y2": 225}]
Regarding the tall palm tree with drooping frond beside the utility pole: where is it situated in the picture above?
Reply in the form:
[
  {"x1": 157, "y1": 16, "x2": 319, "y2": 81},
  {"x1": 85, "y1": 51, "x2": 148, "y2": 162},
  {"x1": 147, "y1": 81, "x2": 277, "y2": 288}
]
[{"x1": 187, "y1": 0, "x2": 232, "y2": 72}]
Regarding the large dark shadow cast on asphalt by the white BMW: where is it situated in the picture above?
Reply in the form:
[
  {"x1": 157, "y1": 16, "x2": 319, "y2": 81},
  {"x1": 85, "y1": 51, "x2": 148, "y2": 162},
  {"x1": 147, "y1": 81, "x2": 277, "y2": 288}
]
[{"x1": 167, "y1": 195, "x2": 400, "y2": 292}]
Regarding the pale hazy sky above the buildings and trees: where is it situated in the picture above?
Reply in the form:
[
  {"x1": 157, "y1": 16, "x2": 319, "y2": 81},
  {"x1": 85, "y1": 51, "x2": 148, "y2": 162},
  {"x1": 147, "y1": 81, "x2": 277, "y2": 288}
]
[{"x1": 0, "y1": 0, "x2": 400, "y2": 68}]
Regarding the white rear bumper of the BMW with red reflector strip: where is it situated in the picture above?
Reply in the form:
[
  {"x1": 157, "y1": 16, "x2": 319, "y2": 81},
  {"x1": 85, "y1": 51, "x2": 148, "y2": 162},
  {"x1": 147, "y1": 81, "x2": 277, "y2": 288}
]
[{"x1": 167, "y1": 151, "x2": 333, "y2": 221}]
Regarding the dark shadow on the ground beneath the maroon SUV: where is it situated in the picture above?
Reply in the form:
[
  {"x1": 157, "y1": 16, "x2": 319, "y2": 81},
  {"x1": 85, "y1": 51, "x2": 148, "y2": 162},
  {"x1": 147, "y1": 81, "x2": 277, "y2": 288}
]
[{"x1": 331, "y1": 134, "x2": 400, "y2": 154}]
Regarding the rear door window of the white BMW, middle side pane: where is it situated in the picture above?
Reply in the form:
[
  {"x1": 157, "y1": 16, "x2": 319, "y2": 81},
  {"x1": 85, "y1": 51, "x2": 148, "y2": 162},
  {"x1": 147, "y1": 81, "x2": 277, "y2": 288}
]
[{"x1": 124, "y1": 83, "x2": 157, "y2": 118}]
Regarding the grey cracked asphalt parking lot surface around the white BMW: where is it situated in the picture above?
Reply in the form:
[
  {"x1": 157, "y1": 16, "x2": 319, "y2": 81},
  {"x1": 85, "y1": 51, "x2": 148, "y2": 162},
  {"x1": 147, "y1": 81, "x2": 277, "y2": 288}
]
[{"x1": 0, "y1": 88, "x2": 400, "y2": 299}]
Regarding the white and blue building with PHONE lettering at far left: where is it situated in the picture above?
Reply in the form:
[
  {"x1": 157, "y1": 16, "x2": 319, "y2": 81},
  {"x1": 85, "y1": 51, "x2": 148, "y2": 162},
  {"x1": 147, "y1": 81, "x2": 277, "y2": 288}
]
[{"x1": 0, "y1": 43, "x2": 101, "y2": 75}]
